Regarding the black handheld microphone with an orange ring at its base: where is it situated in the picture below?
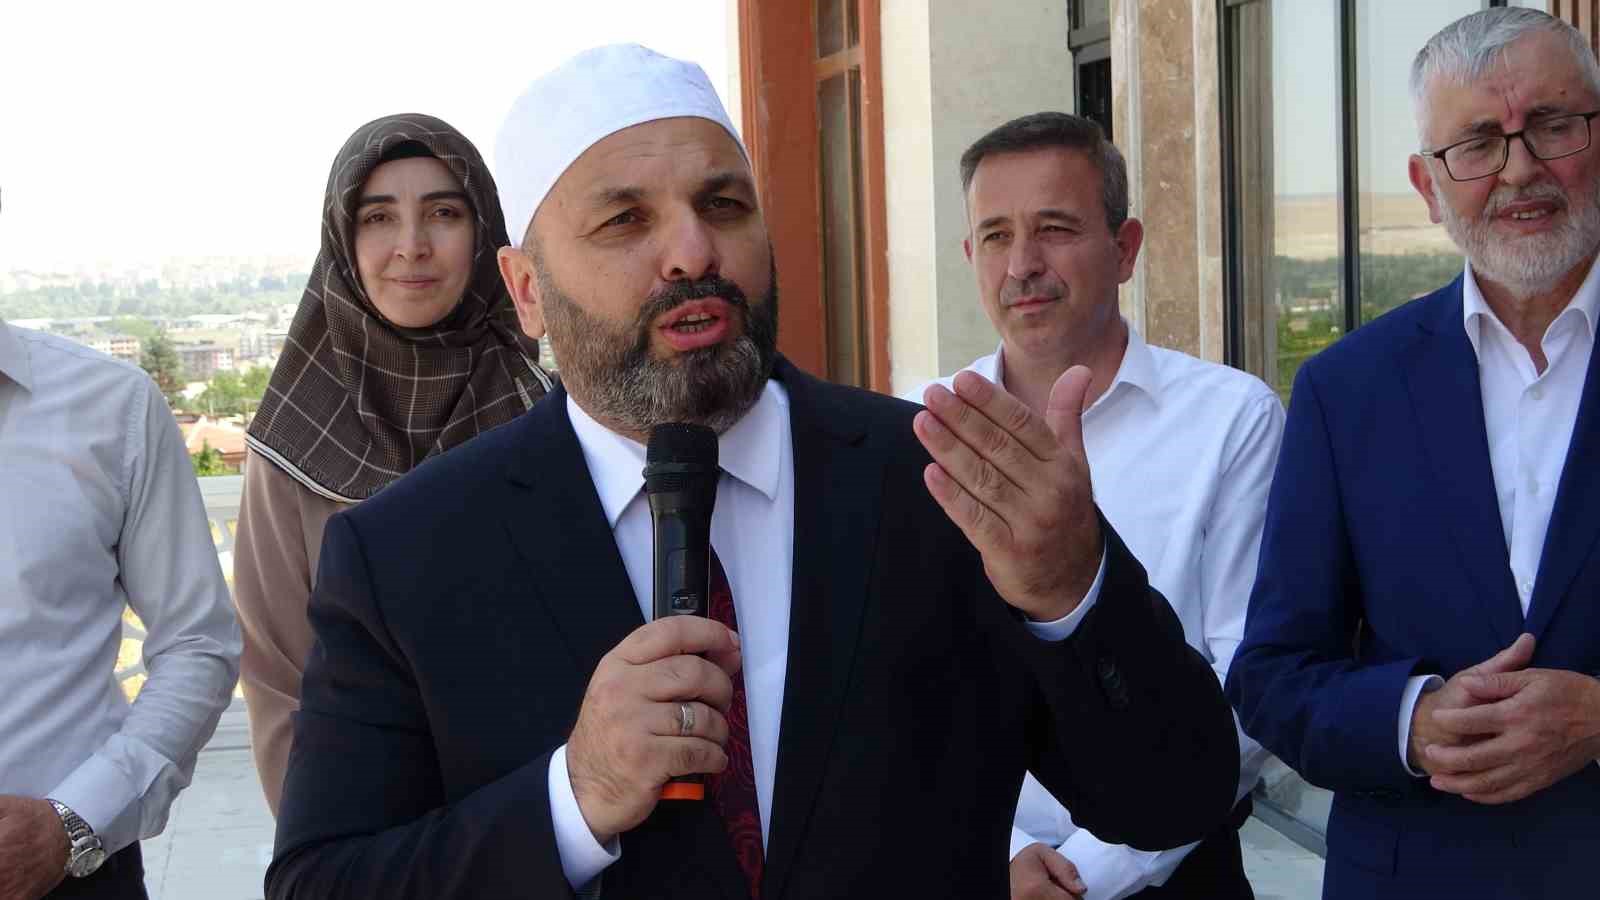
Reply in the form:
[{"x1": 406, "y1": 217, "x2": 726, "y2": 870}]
[{"x1": 645, "y1": 423, "x2": 720, "y2": 801}]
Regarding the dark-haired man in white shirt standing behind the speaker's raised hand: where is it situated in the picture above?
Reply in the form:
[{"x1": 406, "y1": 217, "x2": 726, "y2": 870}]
[{"x1": 906, "y1": 112, "x2": 1283, "y2": 900}]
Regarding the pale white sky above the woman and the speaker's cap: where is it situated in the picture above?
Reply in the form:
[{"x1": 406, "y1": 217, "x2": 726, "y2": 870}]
[{"x1": 0, "y1": 0, "x2": 738, "y2": 271}]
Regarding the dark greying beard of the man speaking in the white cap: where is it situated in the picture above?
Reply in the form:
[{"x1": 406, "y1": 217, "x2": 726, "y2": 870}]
[{"x1": 538, "y1": 266, "x2": 778, "y2": 434}]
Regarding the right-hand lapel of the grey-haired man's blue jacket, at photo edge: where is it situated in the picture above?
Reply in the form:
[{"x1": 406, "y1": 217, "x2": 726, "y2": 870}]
[{"x1": 1526, "y1": 331, "x2": 1600, "y2": 637}]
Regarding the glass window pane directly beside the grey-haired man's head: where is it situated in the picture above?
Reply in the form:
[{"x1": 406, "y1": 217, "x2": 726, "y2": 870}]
[{"x1": 1355, "y1": 0, "x2": 1482, "y2": 322}]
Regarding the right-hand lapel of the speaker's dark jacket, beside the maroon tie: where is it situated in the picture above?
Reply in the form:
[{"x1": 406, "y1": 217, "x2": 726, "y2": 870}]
[{"x1": 762, "y1": 360, "x2": 883, "y2": 900}]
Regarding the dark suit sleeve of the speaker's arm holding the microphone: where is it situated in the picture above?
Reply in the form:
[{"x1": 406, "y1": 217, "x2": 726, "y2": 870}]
[{"x1": 267, "y1": 514, "x2": 573, "y2": 900}]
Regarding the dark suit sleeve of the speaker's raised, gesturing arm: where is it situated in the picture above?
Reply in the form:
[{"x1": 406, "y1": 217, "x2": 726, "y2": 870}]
[{"x1": 1018, "y1": 519, "x2": 1238, "y2": 850}]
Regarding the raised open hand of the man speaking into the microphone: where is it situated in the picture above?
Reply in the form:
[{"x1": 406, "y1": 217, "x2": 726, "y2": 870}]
[{"x1": 914, "y1": 365, "x2": 1104, "y2": 621}]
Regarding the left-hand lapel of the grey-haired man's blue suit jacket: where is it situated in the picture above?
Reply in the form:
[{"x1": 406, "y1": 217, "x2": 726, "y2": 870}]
[{"x1": 1406, "y1": 279, "x2": 1522, "y2": 647}]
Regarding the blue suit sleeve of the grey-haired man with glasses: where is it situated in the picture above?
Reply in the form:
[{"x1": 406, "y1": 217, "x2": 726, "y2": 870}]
[{"x1": 1227, "y1": 367, "x2": 1419, "y2": 791}]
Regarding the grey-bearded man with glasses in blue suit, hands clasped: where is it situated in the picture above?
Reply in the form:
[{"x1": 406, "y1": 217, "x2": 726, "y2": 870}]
[{"x1": 1227, "y1": 8, "x2": 1600, "y2": 900}]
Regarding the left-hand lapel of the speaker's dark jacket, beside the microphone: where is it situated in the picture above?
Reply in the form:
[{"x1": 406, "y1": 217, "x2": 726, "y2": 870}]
[{"x1": 502, "y1": 381, "x2": 645, "y2": 698}]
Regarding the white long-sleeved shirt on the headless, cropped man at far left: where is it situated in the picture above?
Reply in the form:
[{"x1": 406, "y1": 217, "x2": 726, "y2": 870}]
[{"x1": 0, "y1": 322, "x2": 240, "y2": 852}]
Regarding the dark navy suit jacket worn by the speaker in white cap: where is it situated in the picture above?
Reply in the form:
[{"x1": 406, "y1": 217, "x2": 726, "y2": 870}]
[{"x1": 267, "y1": 362, "x2": 1238, "y2": 900}]
